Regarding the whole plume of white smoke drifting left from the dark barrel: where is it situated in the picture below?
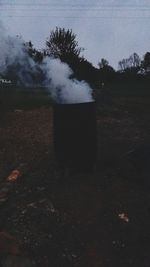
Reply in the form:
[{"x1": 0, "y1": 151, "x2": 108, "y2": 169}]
[{"x1": 0, "y1": 22, "x2": 93, "y2": 103}]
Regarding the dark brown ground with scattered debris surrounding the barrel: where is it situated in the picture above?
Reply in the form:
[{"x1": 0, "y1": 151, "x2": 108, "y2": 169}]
[{"x1": 0, "y1": 97, "x2": 150, "y2": 267}]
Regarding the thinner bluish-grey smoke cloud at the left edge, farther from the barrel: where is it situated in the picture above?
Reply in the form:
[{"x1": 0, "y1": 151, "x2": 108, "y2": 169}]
[{"x1": 0, "y1": 22, "x2": 44, "y2": 86}]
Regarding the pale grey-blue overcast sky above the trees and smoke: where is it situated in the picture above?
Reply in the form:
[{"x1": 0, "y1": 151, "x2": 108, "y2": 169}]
[{"x1": 0, "y1": 0, "x2": 150, "y2": 69}]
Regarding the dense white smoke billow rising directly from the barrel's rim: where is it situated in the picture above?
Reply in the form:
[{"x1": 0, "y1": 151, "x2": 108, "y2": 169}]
[{"x1": 44, "y1": 58, "x2": 92, "y2": 103}]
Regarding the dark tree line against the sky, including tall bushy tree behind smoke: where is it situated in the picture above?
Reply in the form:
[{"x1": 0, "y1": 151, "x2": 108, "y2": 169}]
[{"x1": 0, "y1": 27, "x2": 150, "y2": 91}]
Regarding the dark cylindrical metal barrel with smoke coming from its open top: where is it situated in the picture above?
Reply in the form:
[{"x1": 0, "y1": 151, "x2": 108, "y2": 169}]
[{"x1": 53, "y1": 101, "x2": 97, "y2": 171}]
